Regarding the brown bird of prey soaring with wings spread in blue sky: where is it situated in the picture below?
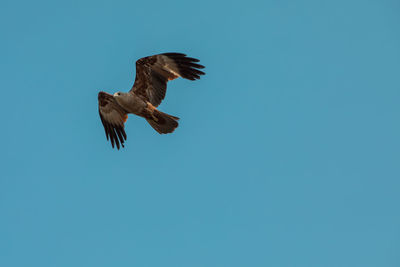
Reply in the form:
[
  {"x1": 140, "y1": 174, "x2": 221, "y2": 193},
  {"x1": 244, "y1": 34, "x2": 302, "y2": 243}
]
[{"x1": 98, "y1": 53, "x2": 204, "y2": 149}]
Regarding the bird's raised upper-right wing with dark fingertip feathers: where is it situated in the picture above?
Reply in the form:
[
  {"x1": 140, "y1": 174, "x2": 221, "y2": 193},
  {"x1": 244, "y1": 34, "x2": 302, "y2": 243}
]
[{"x1": 130, "y1": 53, "x2": 204, "y2": 107}]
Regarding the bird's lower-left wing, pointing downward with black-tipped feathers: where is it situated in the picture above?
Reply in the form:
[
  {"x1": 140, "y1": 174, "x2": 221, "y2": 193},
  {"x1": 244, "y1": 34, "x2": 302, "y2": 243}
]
[{"x1": 98, "y1": 92, "x2": 128, "y2": 149}]
